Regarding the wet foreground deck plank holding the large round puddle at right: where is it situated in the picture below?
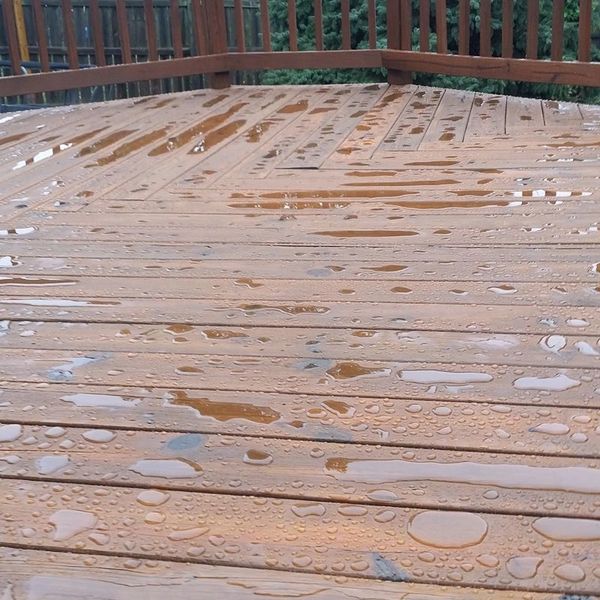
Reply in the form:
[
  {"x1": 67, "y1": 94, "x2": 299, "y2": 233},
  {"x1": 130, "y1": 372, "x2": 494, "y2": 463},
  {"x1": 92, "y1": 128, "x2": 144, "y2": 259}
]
[{"x1": 0, "y1": 480, "x2": 600, "y2": 592}]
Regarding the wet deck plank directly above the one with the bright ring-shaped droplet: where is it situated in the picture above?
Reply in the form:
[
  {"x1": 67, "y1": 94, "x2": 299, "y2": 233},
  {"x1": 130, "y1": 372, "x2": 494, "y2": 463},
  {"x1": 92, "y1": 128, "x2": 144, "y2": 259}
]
[{"x1": 0, "y1": 294, "x2": 600, "y2": 337}]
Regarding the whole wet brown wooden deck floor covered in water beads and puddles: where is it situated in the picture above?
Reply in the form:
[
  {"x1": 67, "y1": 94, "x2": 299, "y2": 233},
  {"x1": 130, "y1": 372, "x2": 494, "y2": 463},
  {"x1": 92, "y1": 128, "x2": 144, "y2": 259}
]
[{"x1": 0, "y1": 85, "x2": 600, "y2": 600}]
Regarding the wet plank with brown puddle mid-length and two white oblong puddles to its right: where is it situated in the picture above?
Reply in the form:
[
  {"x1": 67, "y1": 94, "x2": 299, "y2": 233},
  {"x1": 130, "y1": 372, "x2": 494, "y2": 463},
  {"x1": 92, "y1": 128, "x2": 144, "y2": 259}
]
[{"x1": 0, "y1": 348, "x2": 600, "y2": 408}]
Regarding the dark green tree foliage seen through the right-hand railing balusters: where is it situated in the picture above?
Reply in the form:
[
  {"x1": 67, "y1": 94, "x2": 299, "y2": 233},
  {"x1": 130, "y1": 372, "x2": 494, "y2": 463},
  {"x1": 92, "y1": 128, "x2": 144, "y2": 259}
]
[{"x1": 262, "y1": 0, "x2": 600, "y2": 102}]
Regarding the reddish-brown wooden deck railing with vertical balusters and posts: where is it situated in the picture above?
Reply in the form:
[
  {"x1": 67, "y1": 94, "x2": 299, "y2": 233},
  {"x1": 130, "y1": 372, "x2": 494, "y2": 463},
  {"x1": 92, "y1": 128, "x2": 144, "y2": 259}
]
[{"x1": 0, "y1": 0, "x2": 600, "y2": 96}]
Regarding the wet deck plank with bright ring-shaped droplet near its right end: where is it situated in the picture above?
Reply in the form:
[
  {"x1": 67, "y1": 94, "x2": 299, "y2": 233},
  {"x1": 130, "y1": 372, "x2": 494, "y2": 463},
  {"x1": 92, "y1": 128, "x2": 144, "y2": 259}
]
[{"x1": 0, "y1": 321, "x2": 600, "y2": 369}]
